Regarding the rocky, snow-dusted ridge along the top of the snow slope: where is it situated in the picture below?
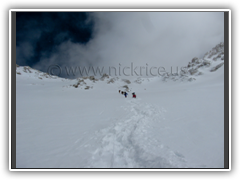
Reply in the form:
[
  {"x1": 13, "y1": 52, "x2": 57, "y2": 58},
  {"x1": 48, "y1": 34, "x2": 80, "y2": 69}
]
[{"x1": 16, "y1": 43, "x2": 224, "y2": 90}]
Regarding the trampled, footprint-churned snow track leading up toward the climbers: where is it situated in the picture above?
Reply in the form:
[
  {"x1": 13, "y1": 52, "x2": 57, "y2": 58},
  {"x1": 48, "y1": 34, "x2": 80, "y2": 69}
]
[{"x1": 85, "y1": 99, "x2": 186, "y2": 168}]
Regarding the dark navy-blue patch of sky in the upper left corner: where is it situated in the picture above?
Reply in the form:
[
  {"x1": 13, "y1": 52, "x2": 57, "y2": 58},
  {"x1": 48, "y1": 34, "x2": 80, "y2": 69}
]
[{"x1": 16, "y1": 12, "x2": 93, "y2": 65}]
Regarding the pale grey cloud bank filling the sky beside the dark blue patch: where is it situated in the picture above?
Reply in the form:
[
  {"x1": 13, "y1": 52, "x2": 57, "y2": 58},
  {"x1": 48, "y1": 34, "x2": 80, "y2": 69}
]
[{"x1": 19, "y1": 12, "x2": 224, "y2": 78}]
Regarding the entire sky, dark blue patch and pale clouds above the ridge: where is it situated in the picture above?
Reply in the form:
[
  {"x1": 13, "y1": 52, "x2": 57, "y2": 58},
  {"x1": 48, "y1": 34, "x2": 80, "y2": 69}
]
[{"x1": 16, "y1": 12, "x2": 224, "y2": 77}]
